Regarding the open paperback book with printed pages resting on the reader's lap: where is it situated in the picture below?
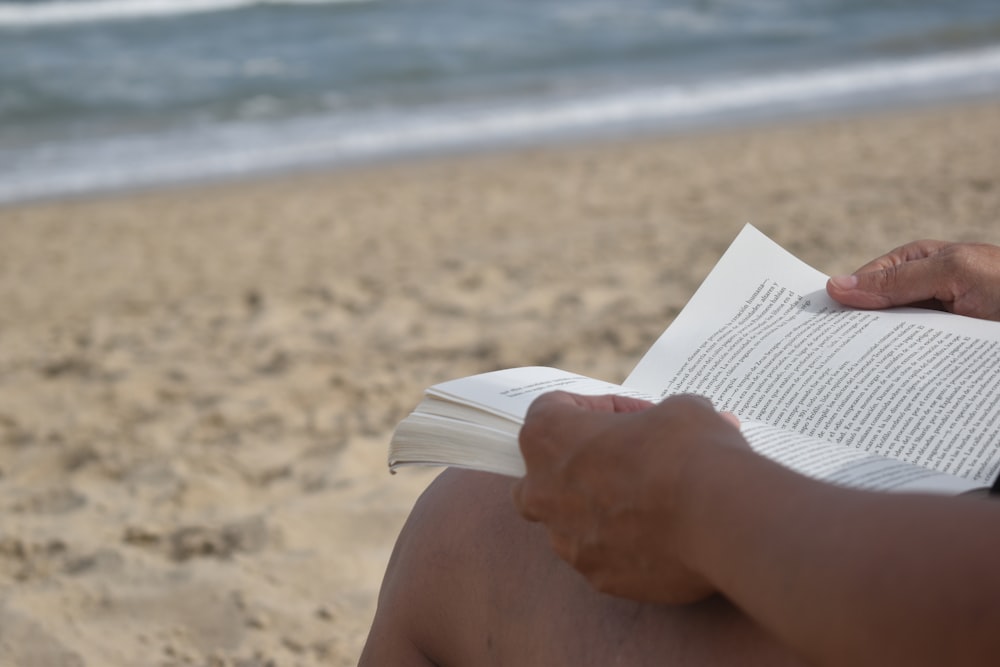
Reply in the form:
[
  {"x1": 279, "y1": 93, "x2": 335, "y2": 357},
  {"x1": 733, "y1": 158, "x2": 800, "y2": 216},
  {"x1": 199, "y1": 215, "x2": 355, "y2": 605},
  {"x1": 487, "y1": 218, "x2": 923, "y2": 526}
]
[{"x1": 389, "y1": 225, "x2": 1000, "y2": 494}]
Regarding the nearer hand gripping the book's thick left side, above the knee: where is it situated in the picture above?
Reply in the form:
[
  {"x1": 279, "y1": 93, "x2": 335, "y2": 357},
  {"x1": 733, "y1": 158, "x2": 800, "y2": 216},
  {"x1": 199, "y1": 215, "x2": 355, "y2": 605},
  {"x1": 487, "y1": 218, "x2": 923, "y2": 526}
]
[{"x1": 514, "y1": 392, "x2": 748, "y2": 604}]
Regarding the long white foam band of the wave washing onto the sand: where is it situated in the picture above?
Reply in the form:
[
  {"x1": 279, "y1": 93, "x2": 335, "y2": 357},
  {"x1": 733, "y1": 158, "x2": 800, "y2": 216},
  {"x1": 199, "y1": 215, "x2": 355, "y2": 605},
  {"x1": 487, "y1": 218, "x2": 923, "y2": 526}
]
[{"x1": 0, "y1": 47, "x2": 1000, "y2": 202}]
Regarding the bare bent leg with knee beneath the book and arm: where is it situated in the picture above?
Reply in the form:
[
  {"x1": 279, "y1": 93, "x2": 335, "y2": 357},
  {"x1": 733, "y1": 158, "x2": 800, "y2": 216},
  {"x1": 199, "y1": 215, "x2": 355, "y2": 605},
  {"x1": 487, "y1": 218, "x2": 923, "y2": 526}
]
[{"x1": 361, "y1": 470, "x2": 799, "y2": 667}]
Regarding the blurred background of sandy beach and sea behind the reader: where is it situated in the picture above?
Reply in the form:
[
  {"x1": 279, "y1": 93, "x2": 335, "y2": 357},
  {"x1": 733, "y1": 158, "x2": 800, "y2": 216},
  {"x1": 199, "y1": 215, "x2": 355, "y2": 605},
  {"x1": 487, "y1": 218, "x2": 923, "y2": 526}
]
[{"x1": 0, "y1": 0, "x2": 1000, "y2": 667}]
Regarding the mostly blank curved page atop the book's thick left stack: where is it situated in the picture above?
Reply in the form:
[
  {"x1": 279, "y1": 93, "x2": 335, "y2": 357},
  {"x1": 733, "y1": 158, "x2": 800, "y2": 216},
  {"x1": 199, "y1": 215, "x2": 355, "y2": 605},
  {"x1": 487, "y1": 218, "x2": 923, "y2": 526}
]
[{"x1": 426, "y1": 366, "x2": 653, "y2": 423}]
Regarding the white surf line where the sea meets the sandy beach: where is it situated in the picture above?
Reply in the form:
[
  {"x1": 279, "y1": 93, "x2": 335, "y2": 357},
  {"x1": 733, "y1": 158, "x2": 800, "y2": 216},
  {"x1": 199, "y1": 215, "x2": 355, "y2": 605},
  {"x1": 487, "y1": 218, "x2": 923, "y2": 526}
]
[{"x1": 0, "y1": 51, "x2": 1000, "y2": 210}]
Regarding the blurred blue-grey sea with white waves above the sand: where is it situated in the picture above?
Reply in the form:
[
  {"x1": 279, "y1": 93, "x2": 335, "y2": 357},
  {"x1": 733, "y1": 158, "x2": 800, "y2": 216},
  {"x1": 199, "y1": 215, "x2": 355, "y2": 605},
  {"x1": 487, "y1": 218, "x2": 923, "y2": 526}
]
[{"x1": 0, "y1": 0, "x2": 1000, "y2": 204}]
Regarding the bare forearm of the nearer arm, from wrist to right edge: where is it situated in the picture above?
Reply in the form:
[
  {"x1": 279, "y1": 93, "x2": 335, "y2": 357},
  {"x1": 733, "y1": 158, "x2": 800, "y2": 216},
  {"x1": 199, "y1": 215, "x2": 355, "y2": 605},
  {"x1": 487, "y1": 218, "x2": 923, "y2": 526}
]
[{"x1": 680, "y1": 452, "x2": 1000, "y2": 665}]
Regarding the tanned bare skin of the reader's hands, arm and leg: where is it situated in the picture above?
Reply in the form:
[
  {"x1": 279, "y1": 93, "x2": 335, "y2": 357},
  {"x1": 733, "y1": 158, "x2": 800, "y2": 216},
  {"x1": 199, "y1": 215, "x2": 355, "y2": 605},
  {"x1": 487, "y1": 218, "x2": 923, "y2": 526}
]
[{"x1": 360, "y1": 242, "x2": 1000, "y2": 667}]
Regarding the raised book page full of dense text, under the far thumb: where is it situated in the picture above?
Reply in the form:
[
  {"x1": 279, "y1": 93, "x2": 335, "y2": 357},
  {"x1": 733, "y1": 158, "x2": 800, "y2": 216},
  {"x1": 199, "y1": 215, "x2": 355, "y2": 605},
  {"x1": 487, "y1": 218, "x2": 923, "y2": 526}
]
[{"x1": 623, "y1": 225, "x2": 1000, "y2": 484}]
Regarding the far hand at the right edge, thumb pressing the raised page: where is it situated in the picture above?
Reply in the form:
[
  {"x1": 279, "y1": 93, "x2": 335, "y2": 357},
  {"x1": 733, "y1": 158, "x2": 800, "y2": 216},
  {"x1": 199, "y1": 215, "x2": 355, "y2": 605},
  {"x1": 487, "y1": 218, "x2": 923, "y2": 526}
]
[{"x1": 826, "y1": 241, "x2": 1000, "y2": 320}]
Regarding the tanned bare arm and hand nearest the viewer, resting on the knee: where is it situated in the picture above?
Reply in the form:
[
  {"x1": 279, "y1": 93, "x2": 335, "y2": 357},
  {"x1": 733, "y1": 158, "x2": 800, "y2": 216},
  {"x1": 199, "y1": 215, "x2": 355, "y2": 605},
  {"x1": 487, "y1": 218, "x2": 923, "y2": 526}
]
[{"x1": 515, "y1": 394, "x2": 1000, "y2": 666}]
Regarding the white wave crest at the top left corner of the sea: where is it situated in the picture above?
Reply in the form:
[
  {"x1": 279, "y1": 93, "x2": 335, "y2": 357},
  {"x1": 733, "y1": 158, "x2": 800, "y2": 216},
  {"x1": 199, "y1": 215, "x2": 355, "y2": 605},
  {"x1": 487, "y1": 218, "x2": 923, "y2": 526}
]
[{"x1": 0, "y1": 0, "x2": 372, "y2": 29}]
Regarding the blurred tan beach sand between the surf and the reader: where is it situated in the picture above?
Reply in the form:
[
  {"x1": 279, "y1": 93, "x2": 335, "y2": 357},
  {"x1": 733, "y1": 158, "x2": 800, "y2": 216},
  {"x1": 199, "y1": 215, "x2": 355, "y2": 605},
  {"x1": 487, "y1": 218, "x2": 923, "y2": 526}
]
[{"x1": 0, "y1": 102, "x2": 1000, "y2": 667}]
